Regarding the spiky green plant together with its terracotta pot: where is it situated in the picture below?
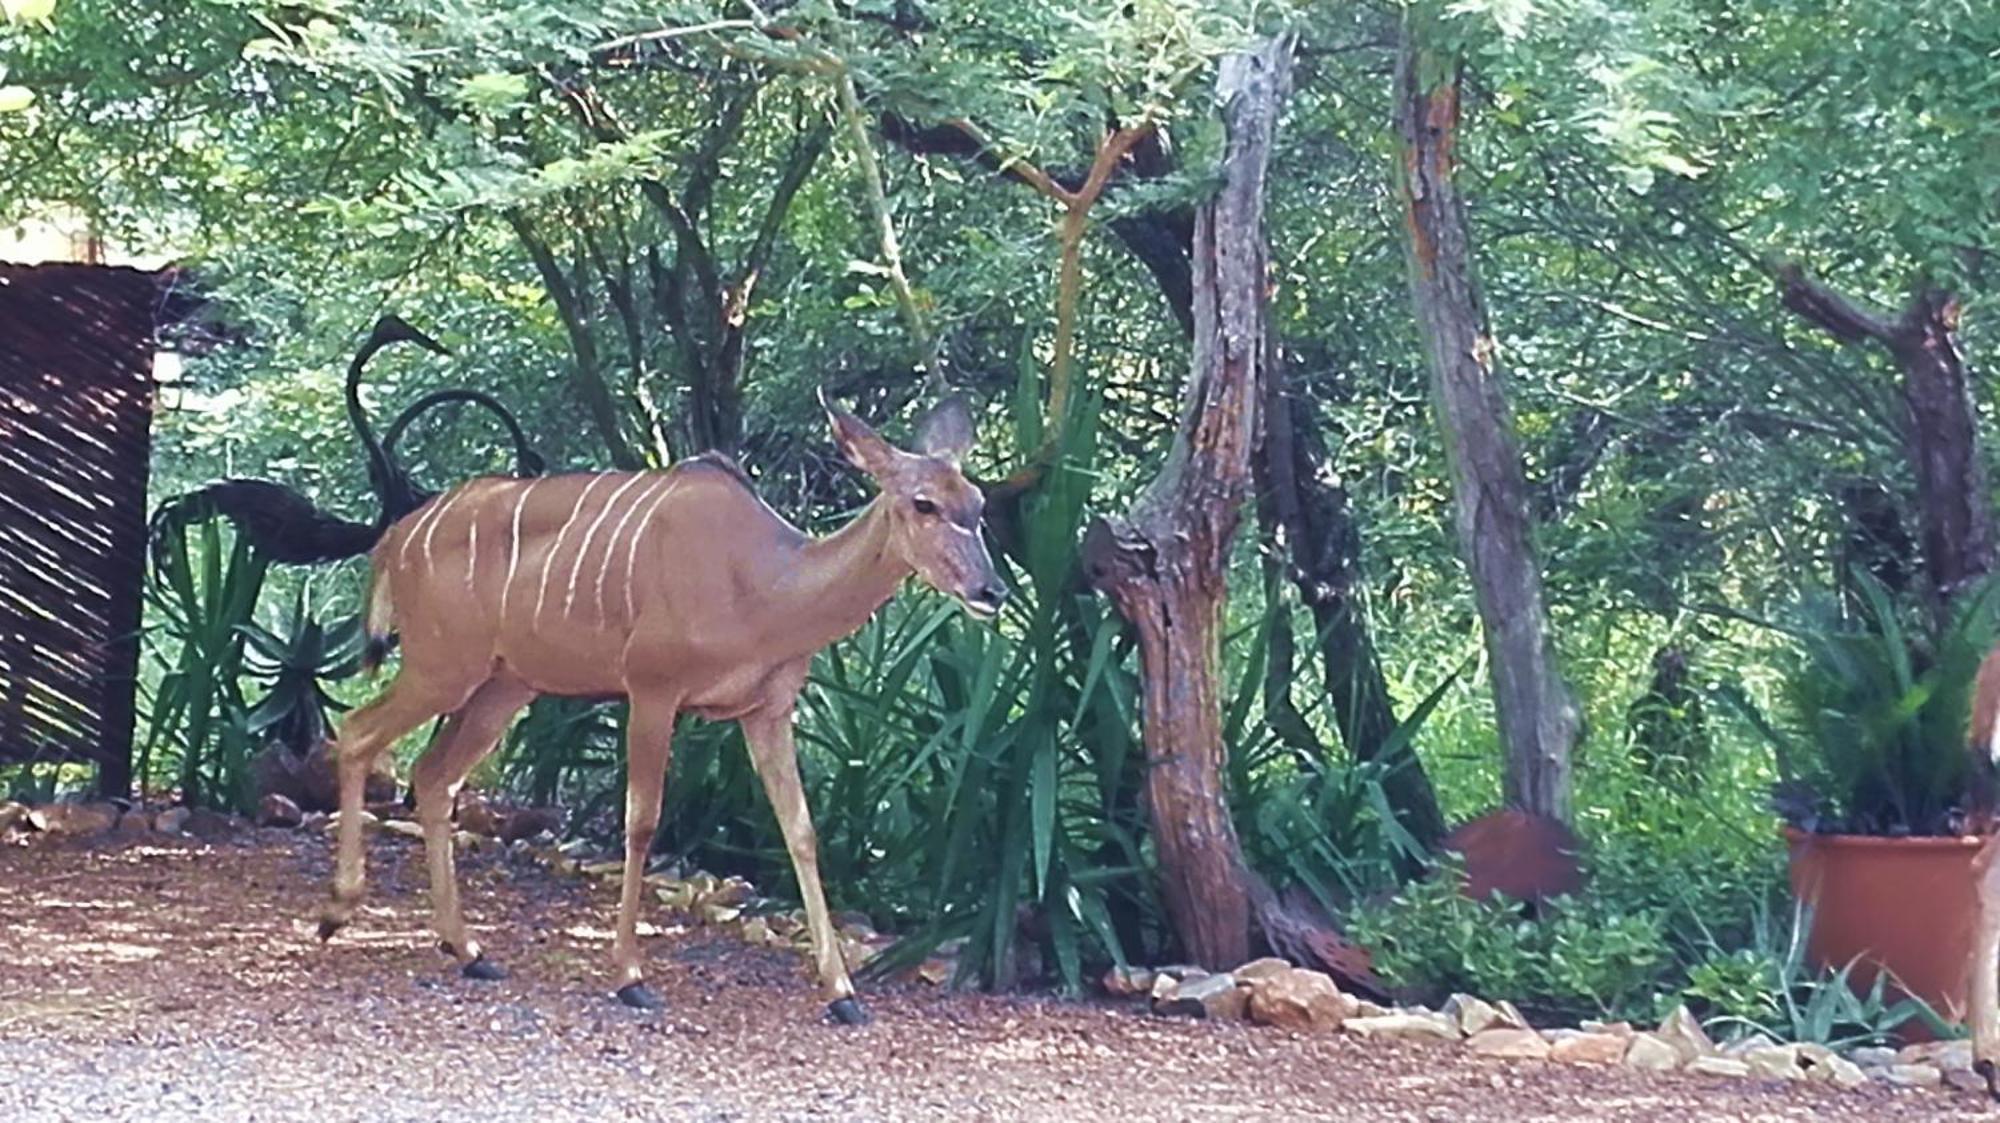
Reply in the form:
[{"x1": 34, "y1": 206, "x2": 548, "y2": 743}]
[{"x1": 1760, "y1": 573, "x2": 1994, "y2": 1021}]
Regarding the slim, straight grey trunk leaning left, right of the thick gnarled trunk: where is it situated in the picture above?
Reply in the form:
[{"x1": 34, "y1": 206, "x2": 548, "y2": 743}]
[{"x1": 1396, "y1": 18, "x2": 1580, "y2": 821}]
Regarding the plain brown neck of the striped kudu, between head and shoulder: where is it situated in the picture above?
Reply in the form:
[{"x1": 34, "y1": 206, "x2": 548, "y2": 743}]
[{"x1": 772, "y1": 498, "x2": 910, "y2": 651}]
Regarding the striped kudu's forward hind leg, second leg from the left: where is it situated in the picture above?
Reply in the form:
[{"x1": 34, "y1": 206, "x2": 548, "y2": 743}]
[{"x1": 410, "y1": 679, "x2": 534, "y2": 979}]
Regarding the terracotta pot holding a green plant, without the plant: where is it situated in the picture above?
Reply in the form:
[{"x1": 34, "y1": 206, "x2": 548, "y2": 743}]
[{"x1": 1784, "y1": 827, "x2": 1984, "y2": 1041}]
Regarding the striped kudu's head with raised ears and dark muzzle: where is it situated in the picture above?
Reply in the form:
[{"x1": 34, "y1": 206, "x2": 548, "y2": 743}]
[{"x1": 820, "y1": 394, "x2": 1006, "y2": 619}]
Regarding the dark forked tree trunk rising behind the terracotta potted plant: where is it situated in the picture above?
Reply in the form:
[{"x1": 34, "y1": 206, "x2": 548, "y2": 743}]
[{"x1": 1778, "y1": 266, "x2": 1994, "y2": 613}]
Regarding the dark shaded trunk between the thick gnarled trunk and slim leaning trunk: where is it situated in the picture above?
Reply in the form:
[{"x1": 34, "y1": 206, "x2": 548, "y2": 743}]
[{"x1": 1254, "y1": 344, "x2": 1444, "y2": 847}]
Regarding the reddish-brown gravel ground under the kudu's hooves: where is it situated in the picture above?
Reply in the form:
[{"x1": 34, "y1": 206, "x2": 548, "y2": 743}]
[{"x1": 0, "y1": 831, "x2": 1990, "y2": 1123}]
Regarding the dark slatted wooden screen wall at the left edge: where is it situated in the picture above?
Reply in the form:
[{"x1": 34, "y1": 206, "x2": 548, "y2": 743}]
[{"x1": 0, "y1": 264, "x2": 168, "y2": 793}]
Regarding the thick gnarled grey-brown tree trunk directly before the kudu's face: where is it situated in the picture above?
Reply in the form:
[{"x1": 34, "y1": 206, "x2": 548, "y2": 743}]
[{"x1": 1084, "y1": 36, "x2": 1292, "y2": 969}]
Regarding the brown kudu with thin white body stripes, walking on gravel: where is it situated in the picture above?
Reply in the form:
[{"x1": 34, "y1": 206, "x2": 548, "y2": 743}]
[{"x1": 320, "y1": 396, "x2": 1006, "y2": 1023}]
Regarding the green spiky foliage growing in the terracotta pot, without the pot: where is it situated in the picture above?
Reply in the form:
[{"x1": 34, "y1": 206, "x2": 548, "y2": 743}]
[{"x1": 1738, "y1": 573, "x2": 1996, "y2": 835}]
